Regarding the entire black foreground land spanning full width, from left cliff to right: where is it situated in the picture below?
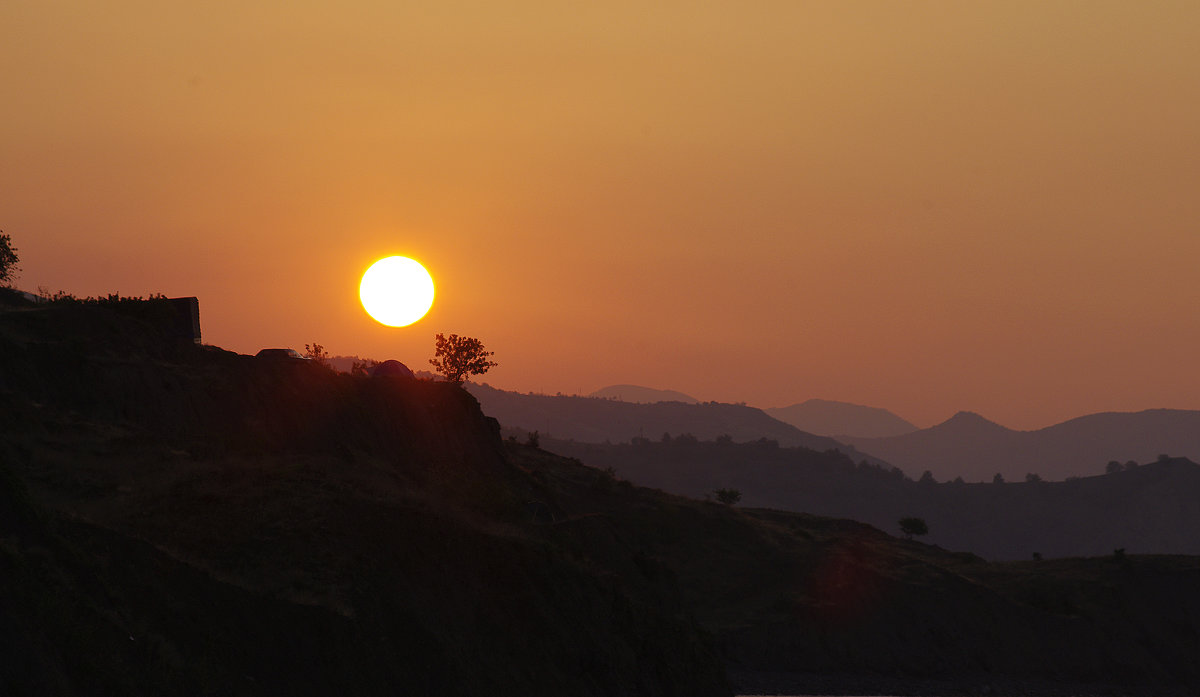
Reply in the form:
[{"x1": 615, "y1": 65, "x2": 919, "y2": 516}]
[{"x1": 0, "y1": 295, "x2": 1200, "y2": 695}]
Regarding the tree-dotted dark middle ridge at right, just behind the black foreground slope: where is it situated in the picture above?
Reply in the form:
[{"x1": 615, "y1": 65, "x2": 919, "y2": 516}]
[{"x1": 541, "y1": 438, "x2": 1200, "y2": 559}]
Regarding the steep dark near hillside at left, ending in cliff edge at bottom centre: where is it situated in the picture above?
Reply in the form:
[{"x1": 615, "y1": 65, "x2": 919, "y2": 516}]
[{"x1": 0, "y1": 297, "x2": 730, "y2": 696}]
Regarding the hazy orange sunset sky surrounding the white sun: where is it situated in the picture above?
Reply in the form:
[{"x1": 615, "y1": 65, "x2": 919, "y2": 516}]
[{"x1": 0, "y1": 0, "x2": 1200, "y2": 428}]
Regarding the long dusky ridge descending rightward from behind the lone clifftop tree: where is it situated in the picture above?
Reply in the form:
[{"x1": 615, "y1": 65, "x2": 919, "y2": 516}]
[{"x1": 464, "y1": 383, "x2": 868, "y2": 452}]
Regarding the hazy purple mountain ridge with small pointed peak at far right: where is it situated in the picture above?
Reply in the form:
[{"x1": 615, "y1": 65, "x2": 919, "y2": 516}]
[{"x1": 845, "y1": 409, "x2": 1200, "y2": 481}]
